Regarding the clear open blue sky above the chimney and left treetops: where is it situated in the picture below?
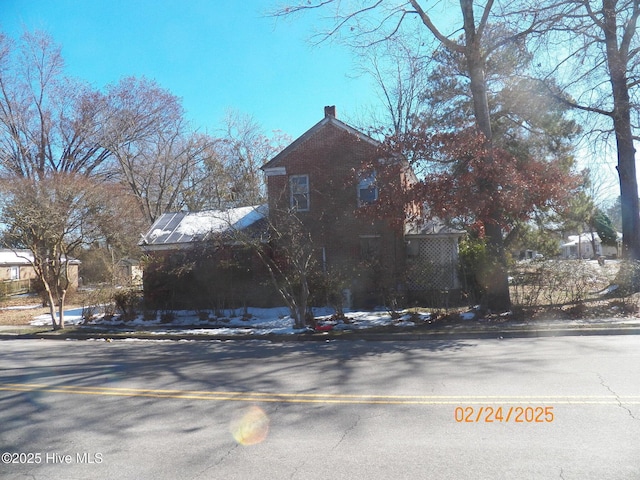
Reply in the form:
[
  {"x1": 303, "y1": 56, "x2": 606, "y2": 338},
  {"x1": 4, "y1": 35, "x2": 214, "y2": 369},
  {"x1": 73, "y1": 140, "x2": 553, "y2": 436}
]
[{"x1": 0, "y1": 0, "x2": 376, "y2": 137}]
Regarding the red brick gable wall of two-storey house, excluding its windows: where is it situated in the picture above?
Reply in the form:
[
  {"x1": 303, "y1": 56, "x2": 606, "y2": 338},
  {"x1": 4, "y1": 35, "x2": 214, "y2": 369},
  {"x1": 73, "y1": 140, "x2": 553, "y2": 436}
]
[{"x1": 267, "y1": 123, "x2": 405, "y2": 305}]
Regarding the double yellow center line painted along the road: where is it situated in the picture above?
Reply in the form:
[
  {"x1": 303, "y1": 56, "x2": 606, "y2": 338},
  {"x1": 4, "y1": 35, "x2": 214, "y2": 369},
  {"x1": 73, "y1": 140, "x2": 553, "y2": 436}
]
[{"x1": 0, "y1": 383, "x2": 640, "y2": 405}]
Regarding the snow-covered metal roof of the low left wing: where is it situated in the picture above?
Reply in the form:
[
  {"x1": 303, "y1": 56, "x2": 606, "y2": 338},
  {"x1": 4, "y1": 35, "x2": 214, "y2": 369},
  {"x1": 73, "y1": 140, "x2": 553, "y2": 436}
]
[{"x1": 140, "y1": 205, "x2": 268, "y2": 248}]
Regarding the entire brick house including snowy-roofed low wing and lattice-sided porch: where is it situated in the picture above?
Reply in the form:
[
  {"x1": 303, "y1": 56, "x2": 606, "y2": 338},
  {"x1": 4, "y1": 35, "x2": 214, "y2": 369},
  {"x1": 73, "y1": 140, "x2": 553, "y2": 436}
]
[{"x1": 143, "y1": 107, "x2": 463, "y2": 306}]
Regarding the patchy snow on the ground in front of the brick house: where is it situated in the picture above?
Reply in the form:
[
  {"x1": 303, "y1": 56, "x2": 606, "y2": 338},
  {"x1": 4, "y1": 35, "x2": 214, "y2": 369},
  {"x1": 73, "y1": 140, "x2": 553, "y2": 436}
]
[{"x1": 30, "y1": 307, "x2": 430, "y2": 336}]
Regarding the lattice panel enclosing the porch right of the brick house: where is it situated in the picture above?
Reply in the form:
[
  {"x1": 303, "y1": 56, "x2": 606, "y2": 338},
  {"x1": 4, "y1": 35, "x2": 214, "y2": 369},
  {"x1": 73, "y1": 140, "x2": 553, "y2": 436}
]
[{"x1": 407, "y1": 238, "x2": 458, "y2": 290}]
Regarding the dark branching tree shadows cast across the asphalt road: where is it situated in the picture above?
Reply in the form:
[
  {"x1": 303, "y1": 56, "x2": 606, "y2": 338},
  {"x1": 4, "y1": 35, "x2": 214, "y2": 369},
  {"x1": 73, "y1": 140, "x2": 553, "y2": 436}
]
[{"x1": 0, "y1": 334, "x2": 564, "y2": 458}]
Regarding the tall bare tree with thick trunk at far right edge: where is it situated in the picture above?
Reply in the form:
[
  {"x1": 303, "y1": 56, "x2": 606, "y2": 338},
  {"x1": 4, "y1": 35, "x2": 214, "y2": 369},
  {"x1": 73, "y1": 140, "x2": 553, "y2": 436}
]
[{"x1": 545, "y1": 0, "x2": 640, "y2": 260}]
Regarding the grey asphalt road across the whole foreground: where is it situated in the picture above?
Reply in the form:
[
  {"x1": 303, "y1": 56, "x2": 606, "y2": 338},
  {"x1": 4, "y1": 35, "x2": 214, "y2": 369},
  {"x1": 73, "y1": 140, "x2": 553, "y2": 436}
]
[{"x1": 0, "y1": 335, "x2": 640, "y2": 480}]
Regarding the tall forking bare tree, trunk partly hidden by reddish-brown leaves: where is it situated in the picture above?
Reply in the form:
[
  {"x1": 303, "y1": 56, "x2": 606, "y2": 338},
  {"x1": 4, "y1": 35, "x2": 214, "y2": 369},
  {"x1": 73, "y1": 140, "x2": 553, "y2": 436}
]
[{"x1": 274, "y1": 0, "x2": 552, "y2": 311}]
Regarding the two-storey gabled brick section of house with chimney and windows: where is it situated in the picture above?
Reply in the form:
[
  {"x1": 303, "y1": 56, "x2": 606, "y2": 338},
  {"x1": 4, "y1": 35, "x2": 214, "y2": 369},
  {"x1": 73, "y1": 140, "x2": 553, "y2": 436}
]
[{"x1": 262, "y1": 107, "x2": 413, "y2": 306}]
